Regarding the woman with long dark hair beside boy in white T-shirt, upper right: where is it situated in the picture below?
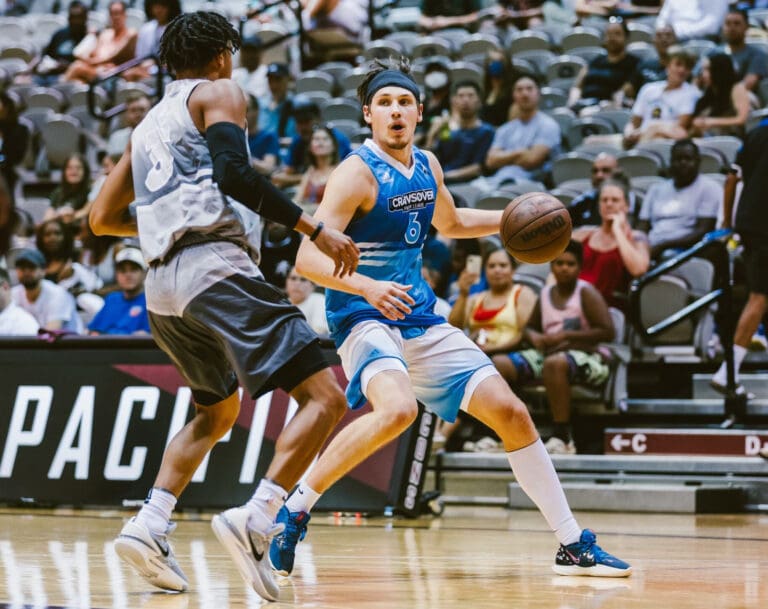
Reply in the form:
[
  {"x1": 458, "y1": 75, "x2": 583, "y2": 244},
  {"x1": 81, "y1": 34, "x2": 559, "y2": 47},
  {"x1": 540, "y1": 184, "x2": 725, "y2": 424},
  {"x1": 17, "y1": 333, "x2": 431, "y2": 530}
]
[{"x1": 689, "y1": 53, "x2": 749, "y2": 138}]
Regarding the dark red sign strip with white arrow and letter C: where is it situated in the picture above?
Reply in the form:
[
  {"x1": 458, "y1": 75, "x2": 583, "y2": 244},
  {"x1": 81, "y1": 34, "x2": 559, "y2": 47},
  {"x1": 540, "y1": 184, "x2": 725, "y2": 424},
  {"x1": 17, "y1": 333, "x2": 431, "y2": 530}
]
[{"x1": 603, "y1": 427, "x2": 768, "y2": 457}]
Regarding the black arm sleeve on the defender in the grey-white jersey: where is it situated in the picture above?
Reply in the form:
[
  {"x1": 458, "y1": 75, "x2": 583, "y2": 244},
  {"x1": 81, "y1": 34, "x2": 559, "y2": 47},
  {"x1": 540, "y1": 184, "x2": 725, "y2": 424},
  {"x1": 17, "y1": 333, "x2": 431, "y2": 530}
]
[{"x1": 205, "y1": 122, "x2": 302, "y2": 228}]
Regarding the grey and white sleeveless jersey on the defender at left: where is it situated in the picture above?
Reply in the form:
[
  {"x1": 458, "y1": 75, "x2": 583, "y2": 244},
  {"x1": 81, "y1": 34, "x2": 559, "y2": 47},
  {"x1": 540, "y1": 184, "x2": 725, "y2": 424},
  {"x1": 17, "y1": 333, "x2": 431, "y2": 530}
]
[{"x1": 131, "y1": 79, "x2": 261, "y2": 262}]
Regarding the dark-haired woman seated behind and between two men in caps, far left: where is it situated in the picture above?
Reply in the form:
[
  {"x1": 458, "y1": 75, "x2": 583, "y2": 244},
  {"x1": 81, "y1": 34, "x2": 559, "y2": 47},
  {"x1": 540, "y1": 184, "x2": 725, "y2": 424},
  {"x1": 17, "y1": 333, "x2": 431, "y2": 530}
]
[{"x1": 36, "y1": 218, "x2": 103, "y2": 297}]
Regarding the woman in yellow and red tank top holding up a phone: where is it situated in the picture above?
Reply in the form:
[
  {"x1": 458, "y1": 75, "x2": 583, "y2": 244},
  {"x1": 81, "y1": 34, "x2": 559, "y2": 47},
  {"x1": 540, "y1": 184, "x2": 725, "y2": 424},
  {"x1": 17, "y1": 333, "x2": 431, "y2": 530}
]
[{"x1": 448, "y1": 248, "x2": 536, "y2": 364}]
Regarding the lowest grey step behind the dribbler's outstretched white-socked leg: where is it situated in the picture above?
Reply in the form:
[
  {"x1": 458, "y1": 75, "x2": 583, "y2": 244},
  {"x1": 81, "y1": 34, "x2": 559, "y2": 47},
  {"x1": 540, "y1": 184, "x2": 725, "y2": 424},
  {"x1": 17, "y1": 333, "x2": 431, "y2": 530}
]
[{"x1": 508, "y1": 482, "x2": 746, "y2": 514}]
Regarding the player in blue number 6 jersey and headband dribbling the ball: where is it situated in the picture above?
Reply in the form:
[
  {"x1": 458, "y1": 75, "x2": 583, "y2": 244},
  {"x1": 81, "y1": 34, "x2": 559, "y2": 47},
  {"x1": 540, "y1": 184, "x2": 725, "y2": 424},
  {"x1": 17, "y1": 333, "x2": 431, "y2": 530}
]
[{"x1": 270, "y1": 60, "x2": 631, "y2": 577}]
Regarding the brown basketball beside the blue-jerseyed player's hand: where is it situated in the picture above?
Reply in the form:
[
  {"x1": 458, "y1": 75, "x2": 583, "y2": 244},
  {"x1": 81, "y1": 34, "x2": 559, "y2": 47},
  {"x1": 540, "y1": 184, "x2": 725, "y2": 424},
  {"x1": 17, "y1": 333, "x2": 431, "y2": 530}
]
[{"x1": 499, "y1": 192, "x2": 571, "y2": 264}]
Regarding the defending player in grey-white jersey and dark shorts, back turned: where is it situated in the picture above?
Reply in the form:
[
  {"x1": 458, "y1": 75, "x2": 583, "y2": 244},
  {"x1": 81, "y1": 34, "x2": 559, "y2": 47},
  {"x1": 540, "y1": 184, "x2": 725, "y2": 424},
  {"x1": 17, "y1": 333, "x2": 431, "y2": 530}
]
[{"x1": 90, "y1": 12, "x2": 358, "y2": 600}]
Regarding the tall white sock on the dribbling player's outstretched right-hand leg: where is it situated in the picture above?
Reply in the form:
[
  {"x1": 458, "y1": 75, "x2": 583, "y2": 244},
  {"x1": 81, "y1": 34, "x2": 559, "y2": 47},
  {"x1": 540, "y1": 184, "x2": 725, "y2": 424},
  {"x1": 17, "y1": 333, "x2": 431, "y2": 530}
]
[{"x1": 507, "y1": 439, "x2": 581, "y2": 546}]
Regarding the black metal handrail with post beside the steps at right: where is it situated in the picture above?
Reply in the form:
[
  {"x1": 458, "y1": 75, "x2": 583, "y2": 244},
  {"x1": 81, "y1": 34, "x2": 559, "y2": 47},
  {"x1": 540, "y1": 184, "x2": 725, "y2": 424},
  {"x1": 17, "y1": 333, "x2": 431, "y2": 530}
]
[{"x1": 629, "y1": 229, "x2": 747, "y2": 427}]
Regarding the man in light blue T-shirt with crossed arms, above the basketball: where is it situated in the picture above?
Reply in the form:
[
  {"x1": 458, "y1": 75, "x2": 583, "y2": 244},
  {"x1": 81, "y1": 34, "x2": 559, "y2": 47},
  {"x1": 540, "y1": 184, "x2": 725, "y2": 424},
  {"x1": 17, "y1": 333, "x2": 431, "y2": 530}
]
[{"x1": 480, "y1": 76, "x2": 561, "y2": 189}]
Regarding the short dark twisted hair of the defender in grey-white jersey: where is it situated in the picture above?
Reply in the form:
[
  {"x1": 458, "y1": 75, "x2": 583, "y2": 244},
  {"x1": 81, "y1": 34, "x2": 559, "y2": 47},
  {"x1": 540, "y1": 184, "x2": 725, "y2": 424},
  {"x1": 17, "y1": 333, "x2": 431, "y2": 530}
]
[{"x1": 159, "y1": 11, "x2": 241, "y2": 74}]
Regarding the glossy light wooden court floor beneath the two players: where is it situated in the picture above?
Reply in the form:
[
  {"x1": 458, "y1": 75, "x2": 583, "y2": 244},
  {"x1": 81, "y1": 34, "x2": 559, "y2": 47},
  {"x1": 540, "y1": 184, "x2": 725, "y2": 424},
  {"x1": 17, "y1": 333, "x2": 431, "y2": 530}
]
[{"x1": 0, "y1": 507, "x2": 768, "y2": 609}]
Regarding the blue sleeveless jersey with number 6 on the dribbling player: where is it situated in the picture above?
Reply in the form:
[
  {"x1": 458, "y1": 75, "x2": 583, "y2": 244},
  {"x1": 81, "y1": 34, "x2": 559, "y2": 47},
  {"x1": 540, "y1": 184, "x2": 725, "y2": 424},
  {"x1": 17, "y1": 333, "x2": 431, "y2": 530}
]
[{"x1": 325, "y1": 140, "x2": 445, "y2": 345}]
